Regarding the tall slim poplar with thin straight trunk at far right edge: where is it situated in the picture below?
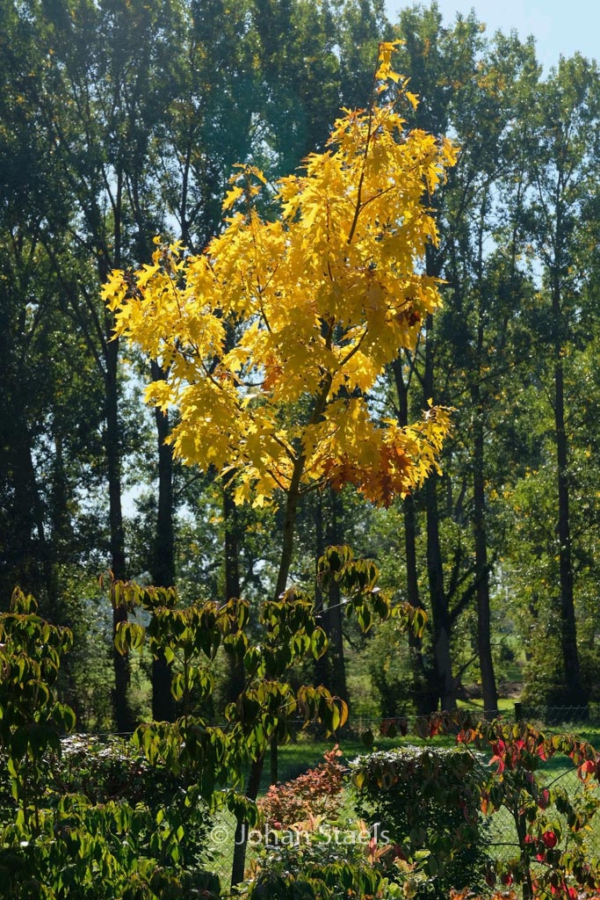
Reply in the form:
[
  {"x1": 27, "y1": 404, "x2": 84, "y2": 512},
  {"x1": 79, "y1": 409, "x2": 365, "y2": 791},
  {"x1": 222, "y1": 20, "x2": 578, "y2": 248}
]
[{"x1": 516, "y1": 56, "x2": 600, "y2": 706}]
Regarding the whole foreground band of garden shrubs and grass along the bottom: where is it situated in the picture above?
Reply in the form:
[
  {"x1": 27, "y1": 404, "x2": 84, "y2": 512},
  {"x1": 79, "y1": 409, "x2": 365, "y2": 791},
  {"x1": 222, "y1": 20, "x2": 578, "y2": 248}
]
[{"x1": 0, "y1": 593, "x2": 600, "y2": 900}]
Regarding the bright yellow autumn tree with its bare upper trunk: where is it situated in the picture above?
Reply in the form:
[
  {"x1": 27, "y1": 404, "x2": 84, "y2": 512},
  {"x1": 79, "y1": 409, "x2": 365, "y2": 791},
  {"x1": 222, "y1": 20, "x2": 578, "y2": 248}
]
[{"x1": 104, "y1": 43, "x2": 455, "y2": 594}]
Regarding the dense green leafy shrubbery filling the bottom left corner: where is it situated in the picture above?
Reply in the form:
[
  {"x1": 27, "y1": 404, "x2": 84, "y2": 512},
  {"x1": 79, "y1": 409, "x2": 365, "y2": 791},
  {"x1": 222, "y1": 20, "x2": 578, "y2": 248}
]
[{"x1": 0, "y1": 591, "x2": 219, "y2": 900}]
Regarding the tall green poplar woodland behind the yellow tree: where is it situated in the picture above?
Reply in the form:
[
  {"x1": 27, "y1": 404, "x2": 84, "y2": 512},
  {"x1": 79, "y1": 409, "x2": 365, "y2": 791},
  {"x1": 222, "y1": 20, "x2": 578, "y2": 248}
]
[{"x1": 0, "y1": 0, "x2": 600, "y2": 731}]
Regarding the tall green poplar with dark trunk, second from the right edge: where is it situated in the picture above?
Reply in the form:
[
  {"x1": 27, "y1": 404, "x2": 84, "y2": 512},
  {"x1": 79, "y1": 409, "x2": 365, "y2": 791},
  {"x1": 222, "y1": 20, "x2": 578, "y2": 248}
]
[{"x1": 380, "y1": 4, "x2": 538, "y2": 713}]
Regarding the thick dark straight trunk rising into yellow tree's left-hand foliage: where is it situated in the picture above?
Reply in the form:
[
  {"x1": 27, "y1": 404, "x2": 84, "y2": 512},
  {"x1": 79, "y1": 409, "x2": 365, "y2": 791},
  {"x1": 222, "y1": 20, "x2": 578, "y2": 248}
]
[{"x1": 151, "y1": 361, "x2": 175, "y2": 722}]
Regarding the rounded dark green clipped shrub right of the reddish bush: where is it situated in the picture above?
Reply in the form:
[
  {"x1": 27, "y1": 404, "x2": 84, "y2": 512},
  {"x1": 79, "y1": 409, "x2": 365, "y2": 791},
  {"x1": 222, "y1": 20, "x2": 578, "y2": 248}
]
[{"x1": 351, "y1": 747, "x2": 489, "y2": 898}]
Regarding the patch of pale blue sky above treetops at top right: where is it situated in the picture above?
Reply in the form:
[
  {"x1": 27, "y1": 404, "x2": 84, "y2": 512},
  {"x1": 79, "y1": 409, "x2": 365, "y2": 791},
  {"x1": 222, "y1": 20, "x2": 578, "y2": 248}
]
[{"x1": 387, "y1": 0, "x2": 600, "y2": 72}]
